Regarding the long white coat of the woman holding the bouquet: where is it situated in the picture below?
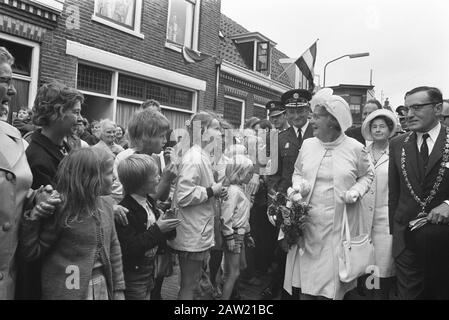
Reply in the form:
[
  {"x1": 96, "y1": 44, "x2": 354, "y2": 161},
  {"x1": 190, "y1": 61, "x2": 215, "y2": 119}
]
[{"x1": 284, "y1": 134, "x2": 374, "y2": 299}]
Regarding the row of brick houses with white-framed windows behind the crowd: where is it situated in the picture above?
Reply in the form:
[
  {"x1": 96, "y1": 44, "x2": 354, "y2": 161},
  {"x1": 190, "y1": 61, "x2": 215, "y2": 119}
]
[{"x1": 0, "y1": 0, "x2": 307, "y2": 128}]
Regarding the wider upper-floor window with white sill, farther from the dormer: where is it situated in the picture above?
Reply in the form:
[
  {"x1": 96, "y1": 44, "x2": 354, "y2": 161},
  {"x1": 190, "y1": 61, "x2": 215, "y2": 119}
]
[{"x1": 92, "y1": 0, "x2": 143, "y2": 38}]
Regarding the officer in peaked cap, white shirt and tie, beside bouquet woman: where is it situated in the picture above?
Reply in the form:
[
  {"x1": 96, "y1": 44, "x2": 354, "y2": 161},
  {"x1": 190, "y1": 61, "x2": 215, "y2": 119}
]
[{"x1": 262, "y1": 89, "x2": 313, "y2": 299}]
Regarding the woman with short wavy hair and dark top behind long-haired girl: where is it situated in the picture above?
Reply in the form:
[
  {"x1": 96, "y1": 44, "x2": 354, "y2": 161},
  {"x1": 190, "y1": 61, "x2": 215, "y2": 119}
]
[{"x1": 17, "y1": 82, "x2": 84, "y2": 300}]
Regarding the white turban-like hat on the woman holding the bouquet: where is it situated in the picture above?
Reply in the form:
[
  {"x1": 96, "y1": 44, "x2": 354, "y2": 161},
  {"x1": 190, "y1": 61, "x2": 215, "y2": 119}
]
[{"x1": 310, "y1": 88, "x2": 352, "y2": 132}]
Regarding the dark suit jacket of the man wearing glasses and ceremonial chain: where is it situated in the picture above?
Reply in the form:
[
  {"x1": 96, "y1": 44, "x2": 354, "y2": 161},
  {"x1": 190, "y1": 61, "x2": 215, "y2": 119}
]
[{"x1": 388, "y1": 126, "x2": 449, "y2": 257}]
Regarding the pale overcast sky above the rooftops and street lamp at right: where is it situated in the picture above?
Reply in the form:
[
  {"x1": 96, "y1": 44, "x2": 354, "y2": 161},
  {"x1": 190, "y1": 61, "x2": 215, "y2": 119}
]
[{"x1": 221, "y1": 0, "x2": 449, "y2": 108}]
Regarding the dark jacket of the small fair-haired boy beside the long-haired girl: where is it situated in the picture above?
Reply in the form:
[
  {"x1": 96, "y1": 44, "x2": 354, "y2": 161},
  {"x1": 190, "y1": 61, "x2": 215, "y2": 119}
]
[{"x1": 115, "y1": 195, "x2": 176, "y2": 272}]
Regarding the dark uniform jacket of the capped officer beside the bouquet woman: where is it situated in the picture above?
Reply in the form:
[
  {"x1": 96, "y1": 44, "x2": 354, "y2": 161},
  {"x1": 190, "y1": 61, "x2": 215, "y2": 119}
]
[{"x1": 269, "y1": 123, "x2": 313, "y2": 193}]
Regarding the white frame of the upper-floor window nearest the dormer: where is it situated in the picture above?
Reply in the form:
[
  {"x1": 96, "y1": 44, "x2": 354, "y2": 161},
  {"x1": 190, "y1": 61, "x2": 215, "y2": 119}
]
[{"x1": 165, "y1": 0, "x2": 201, "y2": 52}]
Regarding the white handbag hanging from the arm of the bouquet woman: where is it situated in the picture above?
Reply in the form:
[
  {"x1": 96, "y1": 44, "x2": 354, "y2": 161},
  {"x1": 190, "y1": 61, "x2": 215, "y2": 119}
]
[{"x1": 338, "y1": 205, "x2": 374, "y2": 283}]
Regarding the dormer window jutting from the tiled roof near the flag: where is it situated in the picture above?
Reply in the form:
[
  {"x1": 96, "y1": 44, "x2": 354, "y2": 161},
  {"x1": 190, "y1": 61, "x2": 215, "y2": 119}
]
[{"x1": 230, "y1": 32, "x2": 276, "y2": 75}]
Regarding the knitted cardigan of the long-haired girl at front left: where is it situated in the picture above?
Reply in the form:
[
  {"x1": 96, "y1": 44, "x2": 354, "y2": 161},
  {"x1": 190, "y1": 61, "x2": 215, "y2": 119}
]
[{"x1": 19, "y1": 197, "x2": 125, "y2": 300}]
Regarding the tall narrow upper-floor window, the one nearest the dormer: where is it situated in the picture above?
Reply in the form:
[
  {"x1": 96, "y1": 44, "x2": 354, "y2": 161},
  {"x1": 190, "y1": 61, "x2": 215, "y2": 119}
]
[{"x1": 167, "y1": 0, "x2": 200, "y2": 50}]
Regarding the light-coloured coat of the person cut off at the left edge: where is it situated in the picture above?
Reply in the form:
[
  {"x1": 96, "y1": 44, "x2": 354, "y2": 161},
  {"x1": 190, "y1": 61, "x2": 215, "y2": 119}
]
[{"x1": 0, "y1": 121, "x2": 33, "y2": 300}]
